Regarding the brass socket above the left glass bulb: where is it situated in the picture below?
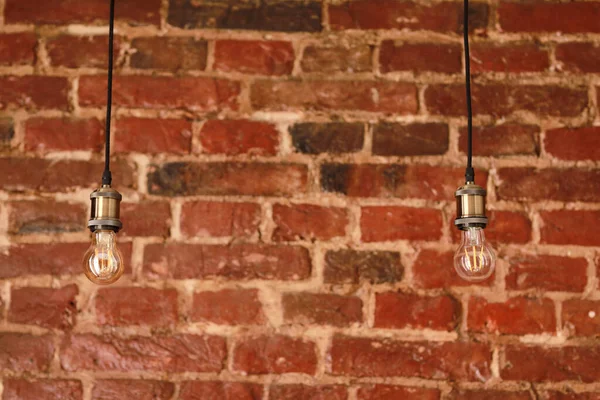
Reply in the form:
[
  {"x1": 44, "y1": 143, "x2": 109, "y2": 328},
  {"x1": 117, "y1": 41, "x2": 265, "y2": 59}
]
[{"x1": 88, "y1": 185, "x2": 123, "y2": 233}]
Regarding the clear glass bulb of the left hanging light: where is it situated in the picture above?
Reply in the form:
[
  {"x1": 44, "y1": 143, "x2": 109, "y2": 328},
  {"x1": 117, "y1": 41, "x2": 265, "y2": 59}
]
[{"x1": 83, "y1": 230, "x2": 125, "y2": 285}]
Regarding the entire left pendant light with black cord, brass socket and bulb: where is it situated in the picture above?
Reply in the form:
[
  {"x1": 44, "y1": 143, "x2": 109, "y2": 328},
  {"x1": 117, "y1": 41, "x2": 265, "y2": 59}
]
[{"x1": 83, "y1": 0, "x2": 124, "y2": 285}]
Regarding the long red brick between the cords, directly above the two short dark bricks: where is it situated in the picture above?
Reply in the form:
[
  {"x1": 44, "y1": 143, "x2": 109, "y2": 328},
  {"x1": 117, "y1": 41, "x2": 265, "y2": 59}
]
[{"x1": 250, "y1": 80, "x2": 417, "y2": 114}]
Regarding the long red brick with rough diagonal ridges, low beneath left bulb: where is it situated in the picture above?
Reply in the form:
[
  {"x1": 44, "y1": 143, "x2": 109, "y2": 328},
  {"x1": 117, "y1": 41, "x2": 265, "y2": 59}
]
[{"x1": 60, "y1": 334, "x2": 227, "y2": 373}]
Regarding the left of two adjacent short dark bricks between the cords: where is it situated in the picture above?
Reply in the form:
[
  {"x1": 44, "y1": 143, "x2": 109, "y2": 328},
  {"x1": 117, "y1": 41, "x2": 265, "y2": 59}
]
[{"x1": 290, "y1": 122, "x2": 365, "y2": 154}]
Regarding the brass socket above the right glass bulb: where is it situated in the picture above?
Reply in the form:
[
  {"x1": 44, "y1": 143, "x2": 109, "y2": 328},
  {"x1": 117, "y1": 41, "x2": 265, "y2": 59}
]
[{"x1": 454, "y1": 182, "x2": 488, "y2": 231}]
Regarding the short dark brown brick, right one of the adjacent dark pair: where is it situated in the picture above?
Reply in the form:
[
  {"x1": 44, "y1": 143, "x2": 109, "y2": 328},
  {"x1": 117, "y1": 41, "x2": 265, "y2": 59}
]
[{"x1": 373, "y1": 122, "x2": 449, "y2": 156}]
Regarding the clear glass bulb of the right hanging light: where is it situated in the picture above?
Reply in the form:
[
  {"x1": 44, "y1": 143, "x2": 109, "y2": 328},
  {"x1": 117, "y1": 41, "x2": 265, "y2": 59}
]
[{"x1": 454, "y1": 228, "x2": 496, "y2": 282}]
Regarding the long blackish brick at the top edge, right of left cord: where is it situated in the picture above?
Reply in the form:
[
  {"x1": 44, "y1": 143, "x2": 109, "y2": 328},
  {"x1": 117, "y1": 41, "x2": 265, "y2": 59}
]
[{"x1": 167, "y1": 0, "x2": 321, "y2": 32}]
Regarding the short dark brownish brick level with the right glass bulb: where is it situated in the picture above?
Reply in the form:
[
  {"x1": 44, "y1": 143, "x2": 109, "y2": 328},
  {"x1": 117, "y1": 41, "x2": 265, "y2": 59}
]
[{"x1": 323, "y1": 250, "x2": 404, "y2": 284}]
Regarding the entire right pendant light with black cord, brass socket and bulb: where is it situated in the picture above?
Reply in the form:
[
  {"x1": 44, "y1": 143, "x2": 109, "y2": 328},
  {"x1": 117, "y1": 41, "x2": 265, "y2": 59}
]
[{"x1": 454, "y1": 0, "x2": 496, "y2": 282}]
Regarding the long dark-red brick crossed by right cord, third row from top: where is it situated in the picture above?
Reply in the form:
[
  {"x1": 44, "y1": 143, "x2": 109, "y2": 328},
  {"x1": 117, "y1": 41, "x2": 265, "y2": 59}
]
[{"x1": 425, "y1": 84, "x2": 588, "y2": 117}]
